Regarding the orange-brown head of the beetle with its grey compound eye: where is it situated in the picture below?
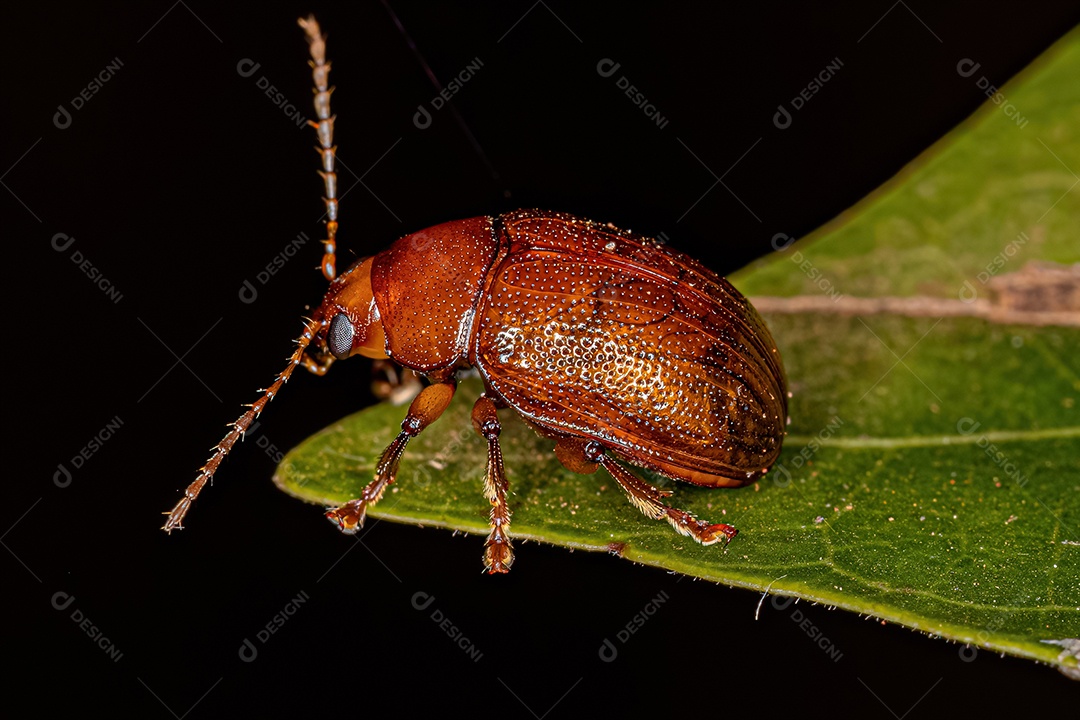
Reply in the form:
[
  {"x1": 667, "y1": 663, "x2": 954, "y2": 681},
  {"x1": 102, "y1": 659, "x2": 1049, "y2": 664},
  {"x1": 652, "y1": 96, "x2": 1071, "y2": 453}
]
[{"x1": 316, "y1": 257, "x2": 388, "y2": 359}]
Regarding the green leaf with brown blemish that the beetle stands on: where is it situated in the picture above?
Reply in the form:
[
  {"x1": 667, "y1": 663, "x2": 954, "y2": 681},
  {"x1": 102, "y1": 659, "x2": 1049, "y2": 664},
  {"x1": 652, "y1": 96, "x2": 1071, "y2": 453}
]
[{"x1": 275, "y1": 31, "x2": 1080, "y2": 675}]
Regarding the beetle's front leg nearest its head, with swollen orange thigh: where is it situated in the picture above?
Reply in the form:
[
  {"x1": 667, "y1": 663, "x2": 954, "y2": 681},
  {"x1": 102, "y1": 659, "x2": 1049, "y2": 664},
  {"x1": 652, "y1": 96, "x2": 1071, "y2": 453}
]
[{"x1": 326, "y1": 378, "x2": 457, "y2": 535}]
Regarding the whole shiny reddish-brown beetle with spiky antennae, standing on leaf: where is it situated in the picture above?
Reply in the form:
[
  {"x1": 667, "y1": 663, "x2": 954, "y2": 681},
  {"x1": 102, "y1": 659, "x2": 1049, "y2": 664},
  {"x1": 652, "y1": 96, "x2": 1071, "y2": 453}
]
[{"x1": 163, "y1": 17, "x2": 787, "y2": 573}]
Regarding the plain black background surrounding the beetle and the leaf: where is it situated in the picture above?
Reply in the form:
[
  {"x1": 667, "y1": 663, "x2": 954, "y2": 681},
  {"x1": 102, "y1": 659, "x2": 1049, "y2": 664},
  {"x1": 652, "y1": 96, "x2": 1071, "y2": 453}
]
[{"x1": 8, "y1": 0, "x2": 1078, "y2": 718}]
